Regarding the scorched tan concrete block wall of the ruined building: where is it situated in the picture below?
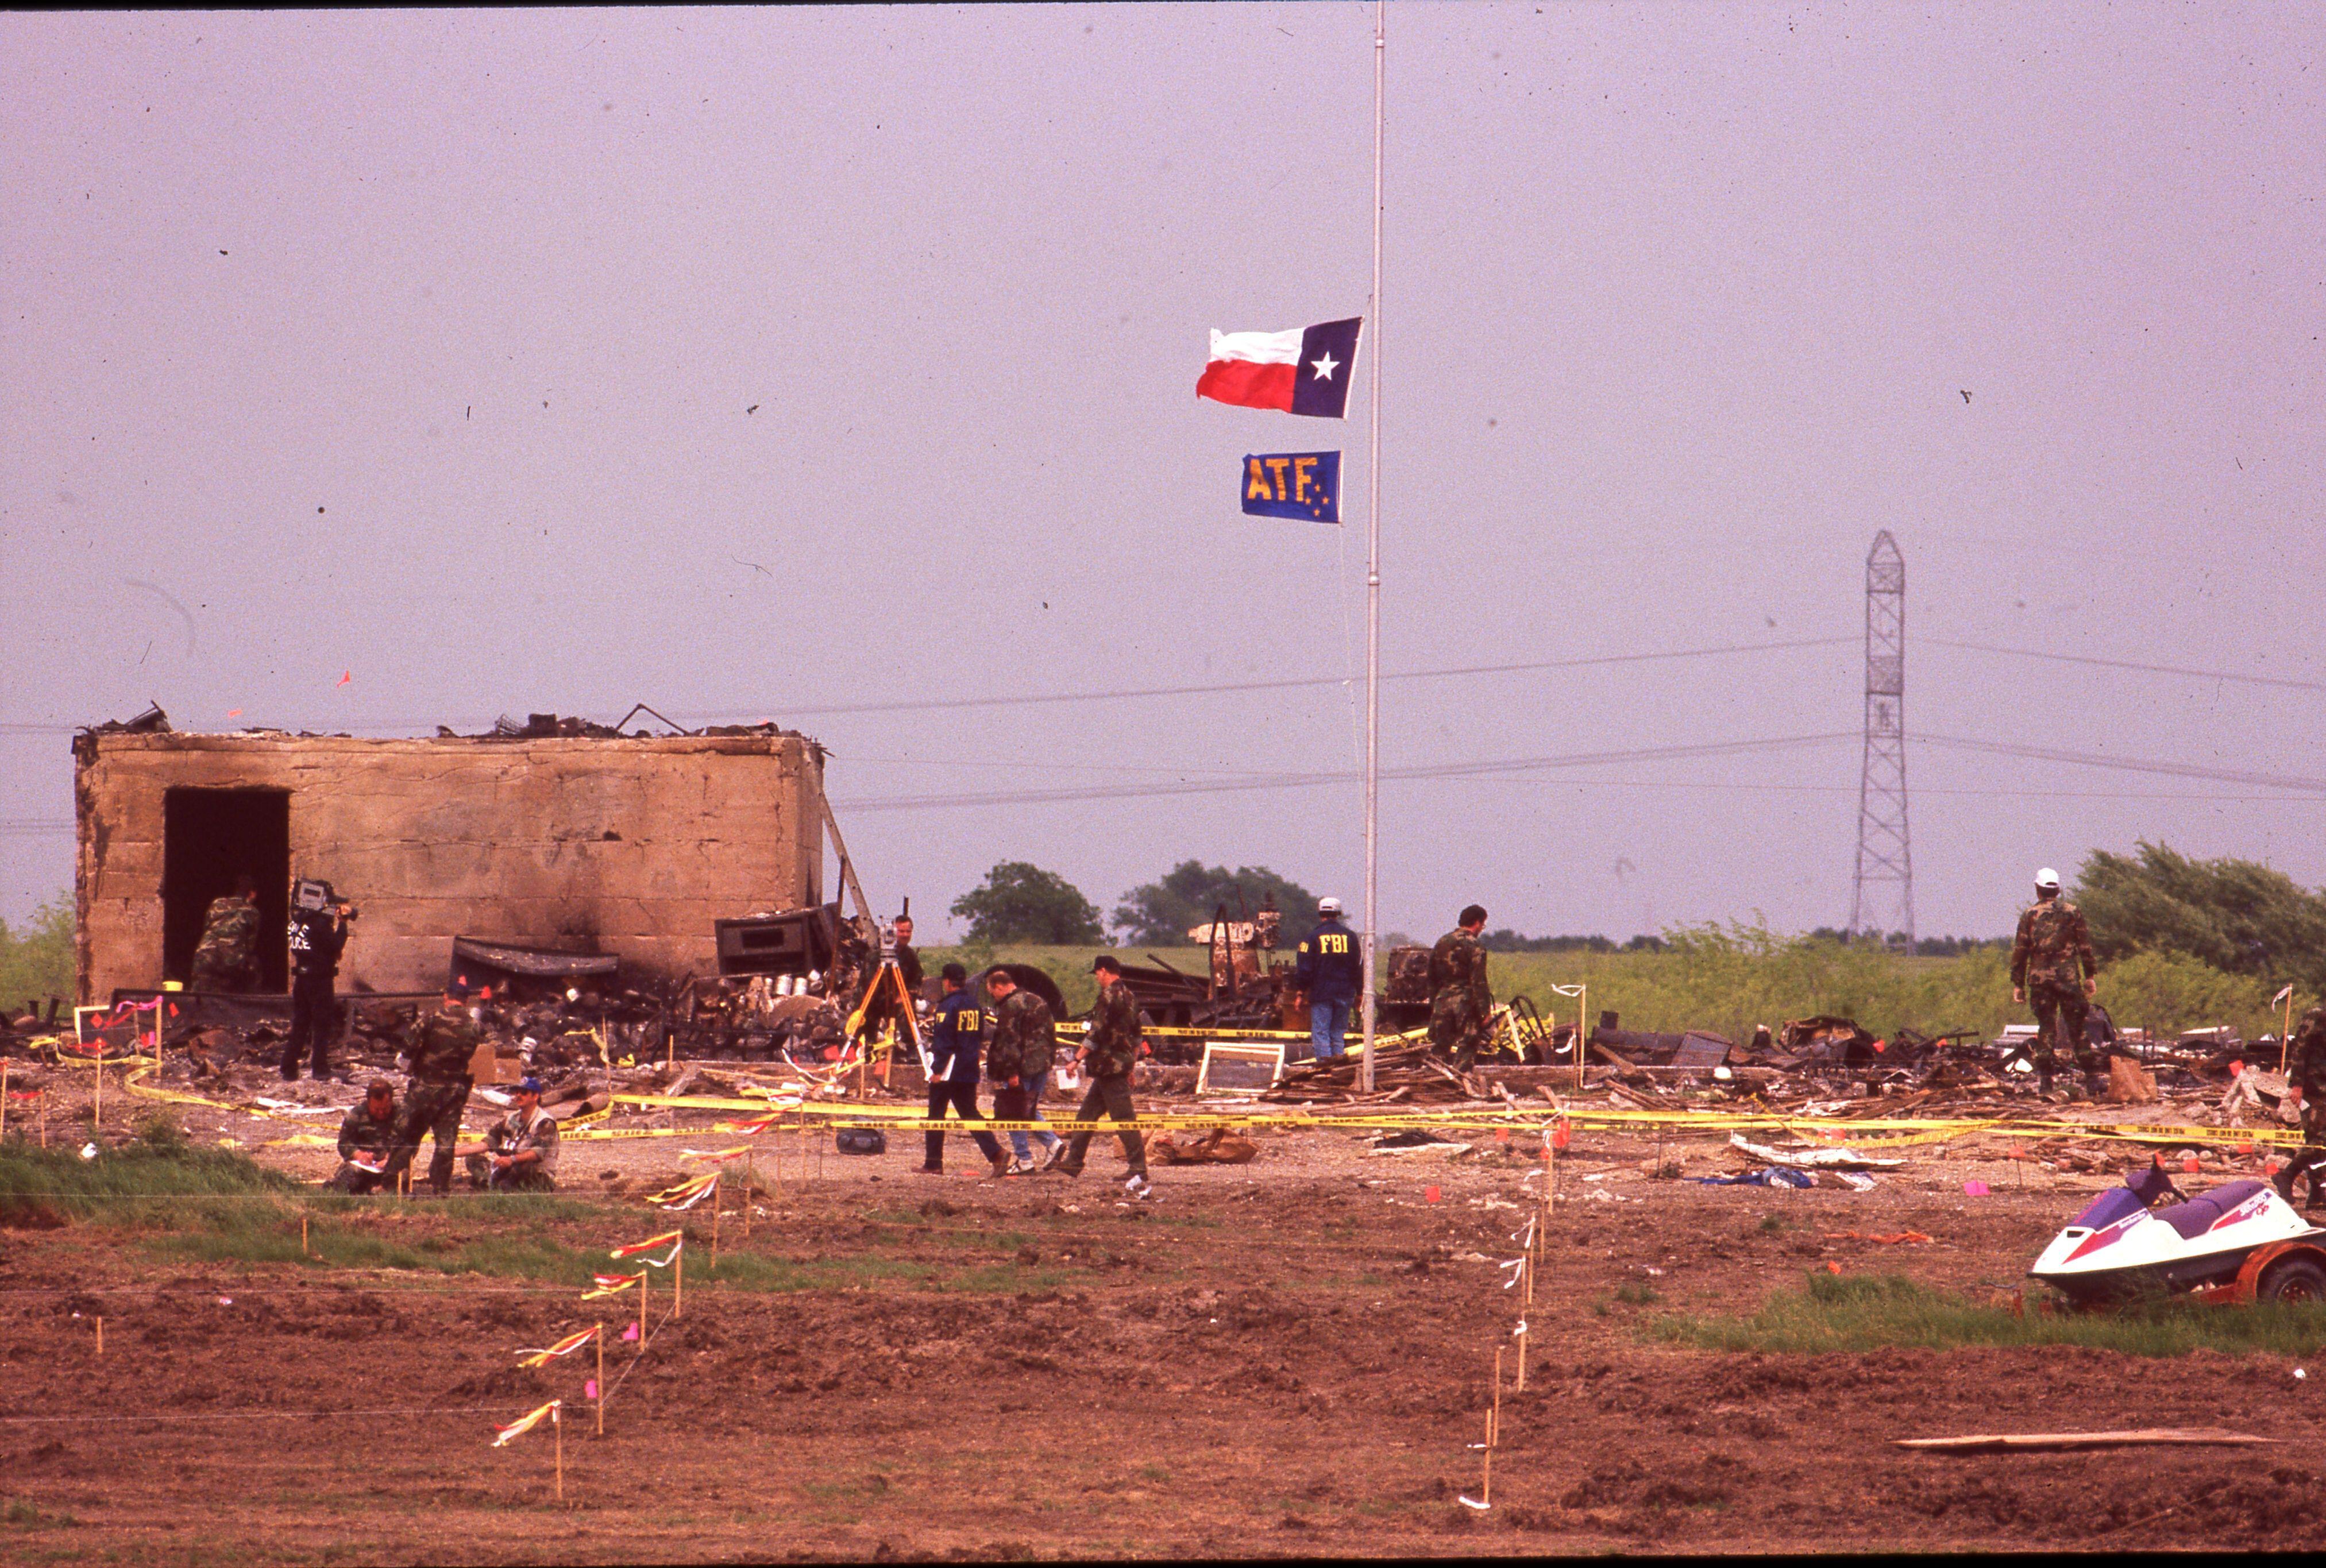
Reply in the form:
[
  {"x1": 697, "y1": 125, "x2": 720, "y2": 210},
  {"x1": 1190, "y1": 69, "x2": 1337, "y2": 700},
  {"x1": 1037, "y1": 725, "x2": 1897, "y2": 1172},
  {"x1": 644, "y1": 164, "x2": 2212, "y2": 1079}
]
[{"x1": 75, "y1": 731, "x2": 823, "y2": 1001}]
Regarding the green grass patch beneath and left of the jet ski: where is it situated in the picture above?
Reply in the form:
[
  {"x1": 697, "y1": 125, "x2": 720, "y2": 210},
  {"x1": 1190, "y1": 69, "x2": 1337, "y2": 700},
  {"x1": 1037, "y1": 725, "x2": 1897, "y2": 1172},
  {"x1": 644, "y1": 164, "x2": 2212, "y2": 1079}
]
[{"x1": 1649, "y1": 1275, "x2": 2326, "y2": 1356}]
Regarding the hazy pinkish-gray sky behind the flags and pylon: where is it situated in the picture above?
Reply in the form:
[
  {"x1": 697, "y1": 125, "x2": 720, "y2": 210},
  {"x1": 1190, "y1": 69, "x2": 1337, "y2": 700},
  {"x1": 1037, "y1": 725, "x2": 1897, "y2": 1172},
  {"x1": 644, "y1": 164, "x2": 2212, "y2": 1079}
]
[{"x1": 0, "y1": 5, "x2": 2326, "y2": 937}]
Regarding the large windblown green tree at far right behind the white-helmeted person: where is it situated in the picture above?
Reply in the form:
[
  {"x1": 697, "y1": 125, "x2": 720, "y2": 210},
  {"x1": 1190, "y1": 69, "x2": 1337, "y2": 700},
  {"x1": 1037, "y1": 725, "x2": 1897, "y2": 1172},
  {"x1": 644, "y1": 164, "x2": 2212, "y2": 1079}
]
[{"x1": 2075, "y1": 840, "x2": 2326, "y2": 988}]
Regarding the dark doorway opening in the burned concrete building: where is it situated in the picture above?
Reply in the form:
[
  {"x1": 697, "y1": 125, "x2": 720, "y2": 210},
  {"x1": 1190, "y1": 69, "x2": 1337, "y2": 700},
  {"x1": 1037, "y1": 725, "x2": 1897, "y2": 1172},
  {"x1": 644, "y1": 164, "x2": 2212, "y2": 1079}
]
[{"x1": 160, "y1": 789, "x2": 291, "y2": 991}]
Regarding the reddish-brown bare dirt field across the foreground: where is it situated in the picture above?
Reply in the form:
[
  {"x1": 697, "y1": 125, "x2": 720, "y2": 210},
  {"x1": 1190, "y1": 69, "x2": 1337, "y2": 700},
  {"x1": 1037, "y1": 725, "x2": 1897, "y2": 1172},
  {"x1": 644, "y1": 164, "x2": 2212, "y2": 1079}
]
[{"x1": 0, "y1": 1088, "x2": 2326, "y2": 1561}]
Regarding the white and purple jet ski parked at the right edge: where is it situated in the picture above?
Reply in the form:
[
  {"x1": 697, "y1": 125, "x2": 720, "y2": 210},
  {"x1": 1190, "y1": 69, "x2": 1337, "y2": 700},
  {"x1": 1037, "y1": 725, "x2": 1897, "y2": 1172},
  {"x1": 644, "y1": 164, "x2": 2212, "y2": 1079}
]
[{"x1": 2028, "y1": 1163, "x2": 2326, "y2": 1303}]
